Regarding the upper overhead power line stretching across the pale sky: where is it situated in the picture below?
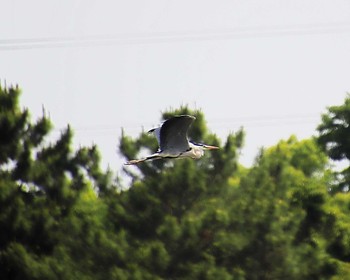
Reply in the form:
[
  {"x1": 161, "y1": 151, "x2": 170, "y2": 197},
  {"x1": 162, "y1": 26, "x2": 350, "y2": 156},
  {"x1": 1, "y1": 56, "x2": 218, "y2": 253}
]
[{"x1": 0, "y1": 22, "x2": 350, "y2": 51}]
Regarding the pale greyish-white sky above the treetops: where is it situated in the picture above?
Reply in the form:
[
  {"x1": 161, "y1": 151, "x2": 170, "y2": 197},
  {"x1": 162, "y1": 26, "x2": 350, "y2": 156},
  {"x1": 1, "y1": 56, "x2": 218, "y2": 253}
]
[{"x1": 0, "y1": 0, "x2": 350, "y2": 175}]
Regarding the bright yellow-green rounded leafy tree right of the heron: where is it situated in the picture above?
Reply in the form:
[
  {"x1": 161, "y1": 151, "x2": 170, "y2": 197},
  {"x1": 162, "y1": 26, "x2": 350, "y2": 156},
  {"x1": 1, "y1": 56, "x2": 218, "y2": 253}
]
[{"x1": 213, "y1": 137, "x2": 337, "y2": 279}]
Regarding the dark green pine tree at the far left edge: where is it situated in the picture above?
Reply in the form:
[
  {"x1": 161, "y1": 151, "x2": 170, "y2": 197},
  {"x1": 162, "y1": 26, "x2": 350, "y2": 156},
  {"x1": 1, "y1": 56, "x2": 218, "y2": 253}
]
[{"x1": 0, "y1": 87, "x2": 127, "y2": 279}]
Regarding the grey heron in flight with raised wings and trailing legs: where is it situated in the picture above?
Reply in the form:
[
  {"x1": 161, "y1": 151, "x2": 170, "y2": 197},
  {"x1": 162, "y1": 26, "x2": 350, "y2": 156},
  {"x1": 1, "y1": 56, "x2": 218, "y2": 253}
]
[{"x1": 125, "y1": 115, "x2": 219, "y2": 165}]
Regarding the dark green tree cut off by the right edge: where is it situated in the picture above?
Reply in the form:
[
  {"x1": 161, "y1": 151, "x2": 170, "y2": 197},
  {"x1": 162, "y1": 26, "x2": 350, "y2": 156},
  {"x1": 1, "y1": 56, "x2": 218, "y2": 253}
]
[{"x1": 317, "y1": 94, "x2": 350, "y2": 279}]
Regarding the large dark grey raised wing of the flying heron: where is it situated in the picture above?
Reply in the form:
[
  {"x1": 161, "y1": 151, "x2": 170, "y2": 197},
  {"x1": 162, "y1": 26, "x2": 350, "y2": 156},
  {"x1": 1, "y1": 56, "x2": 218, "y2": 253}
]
[{"x1": 159, "y1": 115, "x2": 196, "y2": 154}]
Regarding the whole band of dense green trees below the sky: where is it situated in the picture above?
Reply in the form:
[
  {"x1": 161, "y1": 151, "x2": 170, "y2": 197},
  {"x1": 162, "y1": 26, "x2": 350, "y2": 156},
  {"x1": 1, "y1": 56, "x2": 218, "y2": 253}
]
[{"x1": 0, "y1": 87, "x2": 350, "y2": 279}]
